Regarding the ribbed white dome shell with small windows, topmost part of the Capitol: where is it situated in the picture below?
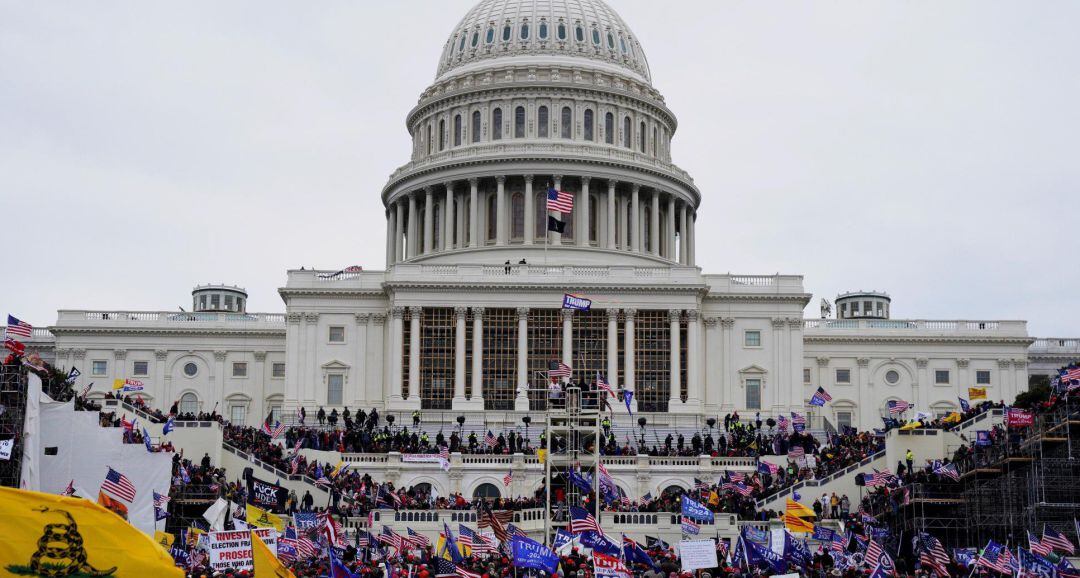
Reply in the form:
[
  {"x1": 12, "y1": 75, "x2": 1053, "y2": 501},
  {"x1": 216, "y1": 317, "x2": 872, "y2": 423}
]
[{"x1": 436, "y1": 0, "x2": 652, "y2": 84}]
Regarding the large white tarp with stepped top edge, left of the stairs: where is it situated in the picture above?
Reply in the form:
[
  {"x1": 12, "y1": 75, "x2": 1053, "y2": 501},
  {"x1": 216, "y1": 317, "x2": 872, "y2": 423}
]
[{"x1": 36, "y1": 395, "x2": 173, "y2": 536}]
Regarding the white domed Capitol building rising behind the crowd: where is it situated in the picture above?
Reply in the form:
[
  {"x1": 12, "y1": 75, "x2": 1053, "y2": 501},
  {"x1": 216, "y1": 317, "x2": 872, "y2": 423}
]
[{"x1": 19, "y1": 0, "x2": 1077, "y2": 438}]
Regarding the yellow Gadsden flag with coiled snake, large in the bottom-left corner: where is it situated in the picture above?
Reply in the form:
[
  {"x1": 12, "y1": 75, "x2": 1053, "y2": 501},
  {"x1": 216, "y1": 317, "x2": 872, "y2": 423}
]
[{"x1": 0, "y1": 487, "x2": 184, "y2": 578}]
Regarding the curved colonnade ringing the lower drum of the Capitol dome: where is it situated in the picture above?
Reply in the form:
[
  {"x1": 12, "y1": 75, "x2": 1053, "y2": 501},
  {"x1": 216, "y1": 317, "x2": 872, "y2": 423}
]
[{"x1": 387, "y1": 174, "x2": 697, "y2": 267}]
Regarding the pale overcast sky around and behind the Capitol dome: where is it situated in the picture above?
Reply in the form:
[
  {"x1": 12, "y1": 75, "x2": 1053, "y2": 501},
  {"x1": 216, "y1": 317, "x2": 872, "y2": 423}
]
[{"x1": 0, "y1": 0, "x2": 1080, "y2": 336}]
